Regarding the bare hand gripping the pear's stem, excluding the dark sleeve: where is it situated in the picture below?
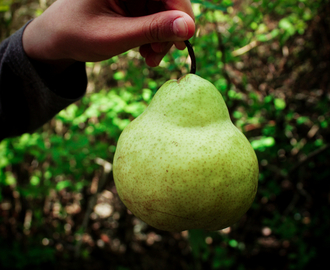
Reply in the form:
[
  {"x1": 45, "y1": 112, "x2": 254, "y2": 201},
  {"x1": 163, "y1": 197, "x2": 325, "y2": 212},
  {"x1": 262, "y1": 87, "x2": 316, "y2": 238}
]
[{"x1": 23, "y1": 0, "x2": 195, "y2": 67}]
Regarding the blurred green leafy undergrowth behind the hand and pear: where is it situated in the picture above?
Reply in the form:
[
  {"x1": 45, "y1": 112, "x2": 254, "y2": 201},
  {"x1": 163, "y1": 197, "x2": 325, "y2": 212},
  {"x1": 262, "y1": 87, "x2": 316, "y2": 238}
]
[{"x1": 0, "y1": 0, "x2": 330, "y2": 270}]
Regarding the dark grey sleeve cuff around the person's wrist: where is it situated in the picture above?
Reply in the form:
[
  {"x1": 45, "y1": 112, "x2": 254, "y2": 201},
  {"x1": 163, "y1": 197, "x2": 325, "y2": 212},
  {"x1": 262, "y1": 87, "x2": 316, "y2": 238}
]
[{"x1": 0, "y1": 21, "x2": 87, "y2": 141}]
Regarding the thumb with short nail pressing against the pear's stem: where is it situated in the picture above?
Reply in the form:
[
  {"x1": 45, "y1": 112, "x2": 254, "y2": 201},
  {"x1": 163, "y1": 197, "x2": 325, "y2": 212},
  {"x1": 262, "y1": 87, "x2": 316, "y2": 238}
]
[{"x1": 132, "y1": 10, "x2": 195, "y2": 46}]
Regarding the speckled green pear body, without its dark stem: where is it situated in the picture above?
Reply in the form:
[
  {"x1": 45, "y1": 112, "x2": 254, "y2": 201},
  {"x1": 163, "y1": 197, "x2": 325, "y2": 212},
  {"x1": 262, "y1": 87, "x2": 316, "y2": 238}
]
[{"x1": 113, "y1": 74, "x2": 258, "y2": 231}]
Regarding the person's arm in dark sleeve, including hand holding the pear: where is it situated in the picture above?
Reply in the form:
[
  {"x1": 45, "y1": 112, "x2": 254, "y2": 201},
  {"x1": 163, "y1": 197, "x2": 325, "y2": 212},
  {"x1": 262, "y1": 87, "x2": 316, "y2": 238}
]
[{"x1": 0, "y1": 0, "x2": 195, "y2": 140}]
